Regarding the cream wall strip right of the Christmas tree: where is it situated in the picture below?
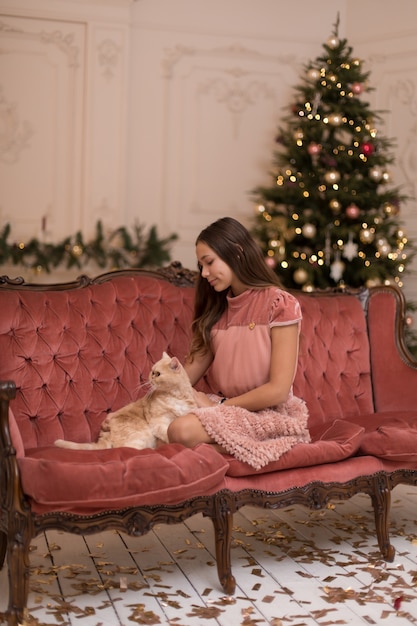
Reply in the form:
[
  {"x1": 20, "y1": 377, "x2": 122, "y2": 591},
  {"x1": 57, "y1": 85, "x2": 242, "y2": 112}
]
[{"x1": 346, "y1": 0, "x2": 417, "y2": 302}]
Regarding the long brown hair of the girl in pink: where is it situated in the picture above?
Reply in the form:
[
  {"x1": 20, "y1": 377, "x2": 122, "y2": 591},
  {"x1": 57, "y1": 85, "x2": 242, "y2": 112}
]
[{"x1": 189, "y1": 217, "x2": 282, "y2": 360}]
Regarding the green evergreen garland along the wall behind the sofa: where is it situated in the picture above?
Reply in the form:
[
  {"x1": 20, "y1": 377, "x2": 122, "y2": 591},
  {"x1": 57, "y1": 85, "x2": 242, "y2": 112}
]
[{"x1": 0, "y1": 221, "x2": 177, "y2": 273}]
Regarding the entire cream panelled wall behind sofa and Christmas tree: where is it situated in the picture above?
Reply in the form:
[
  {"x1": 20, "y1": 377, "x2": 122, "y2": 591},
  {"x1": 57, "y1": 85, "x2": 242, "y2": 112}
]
[{"x1": 0, "y1": 0, "x2": 417, "y2": 299}]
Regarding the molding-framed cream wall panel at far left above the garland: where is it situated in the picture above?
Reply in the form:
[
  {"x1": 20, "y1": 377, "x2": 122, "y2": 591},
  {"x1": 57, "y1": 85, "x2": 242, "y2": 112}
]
[{"x1": 0, "y1": 16, "x2": 85, "y2": 239}]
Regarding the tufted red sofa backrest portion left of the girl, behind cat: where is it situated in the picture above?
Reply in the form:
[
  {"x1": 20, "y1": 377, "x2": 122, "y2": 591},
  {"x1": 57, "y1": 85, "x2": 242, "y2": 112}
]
[{"x1": 0, "y1": 273, "x2": 194, "y2": 448}]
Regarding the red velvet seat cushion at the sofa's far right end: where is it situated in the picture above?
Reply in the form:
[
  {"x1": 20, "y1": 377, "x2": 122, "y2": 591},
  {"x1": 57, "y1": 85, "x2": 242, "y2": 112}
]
[{"x1": 352, "y1": 409, "x2": 417, "y2": 462}]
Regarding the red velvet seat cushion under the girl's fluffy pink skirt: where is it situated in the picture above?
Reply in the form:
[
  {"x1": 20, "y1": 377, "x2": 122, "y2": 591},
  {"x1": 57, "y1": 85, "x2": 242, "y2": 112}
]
[{"x1": 226, "y1": 420, "x2": 365, "y2": 476}]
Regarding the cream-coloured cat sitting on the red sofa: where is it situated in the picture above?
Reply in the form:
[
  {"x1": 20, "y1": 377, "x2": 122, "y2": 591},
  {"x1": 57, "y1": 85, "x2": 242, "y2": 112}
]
[{"x1": 55, "y1": 352, "x2": 197, "y2": 450}]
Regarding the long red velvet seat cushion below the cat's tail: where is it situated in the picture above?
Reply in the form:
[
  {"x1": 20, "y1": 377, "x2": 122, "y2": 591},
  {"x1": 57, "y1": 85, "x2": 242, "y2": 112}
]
[{"x1": 18, "y1": 444, "x2": 227, "y2": 514}]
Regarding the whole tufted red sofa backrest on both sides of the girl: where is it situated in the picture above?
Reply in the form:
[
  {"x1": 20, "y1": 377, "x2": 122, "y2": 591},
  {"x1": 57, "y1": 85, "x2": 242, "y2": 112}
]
[{"x1": 0, "y1": 271, "x2": 373, "y2": 449}]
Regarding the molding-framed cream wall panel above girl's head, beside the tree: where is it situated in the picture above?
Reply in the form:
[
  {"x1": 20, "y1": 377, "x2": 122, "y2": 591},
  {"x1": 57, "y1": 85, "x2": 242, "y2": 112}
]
[{"x1": 161, "y1": 42, "x2": 301, "y2": 241}]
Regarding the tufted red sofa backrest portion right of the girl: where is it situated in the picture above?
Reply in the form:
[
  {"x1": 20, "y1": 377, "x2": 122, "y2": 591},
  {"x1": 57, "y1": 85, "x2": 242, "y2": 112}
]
[{"x1": 294, "y1": 292, "x2": 374, "y2": 424}]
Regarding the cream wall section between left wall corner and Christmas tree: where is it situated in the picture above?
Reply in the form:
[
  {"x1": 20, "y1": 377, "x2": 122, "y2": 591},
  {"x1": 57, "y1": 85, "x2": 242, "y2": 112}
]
[{"x1": 128, "y1": 0, "x2": 345, "y2": 267}]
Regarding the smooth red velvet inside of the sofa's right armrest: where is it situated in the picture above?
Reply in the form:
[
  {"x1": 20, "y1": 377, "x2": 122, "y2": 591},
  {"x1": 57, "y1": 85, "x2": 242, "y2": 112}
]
[{"x1": 368, "y1": 286, "x2": 417, "y2": 411}]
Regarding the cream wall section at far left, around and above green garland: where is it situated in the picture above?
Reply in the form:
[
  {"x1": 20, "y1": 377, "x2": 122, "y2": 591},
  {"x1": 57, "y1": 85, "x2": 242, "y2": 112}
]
[{"x1": 0, "y1": 0, "x2": 131, "y2": 280}]
